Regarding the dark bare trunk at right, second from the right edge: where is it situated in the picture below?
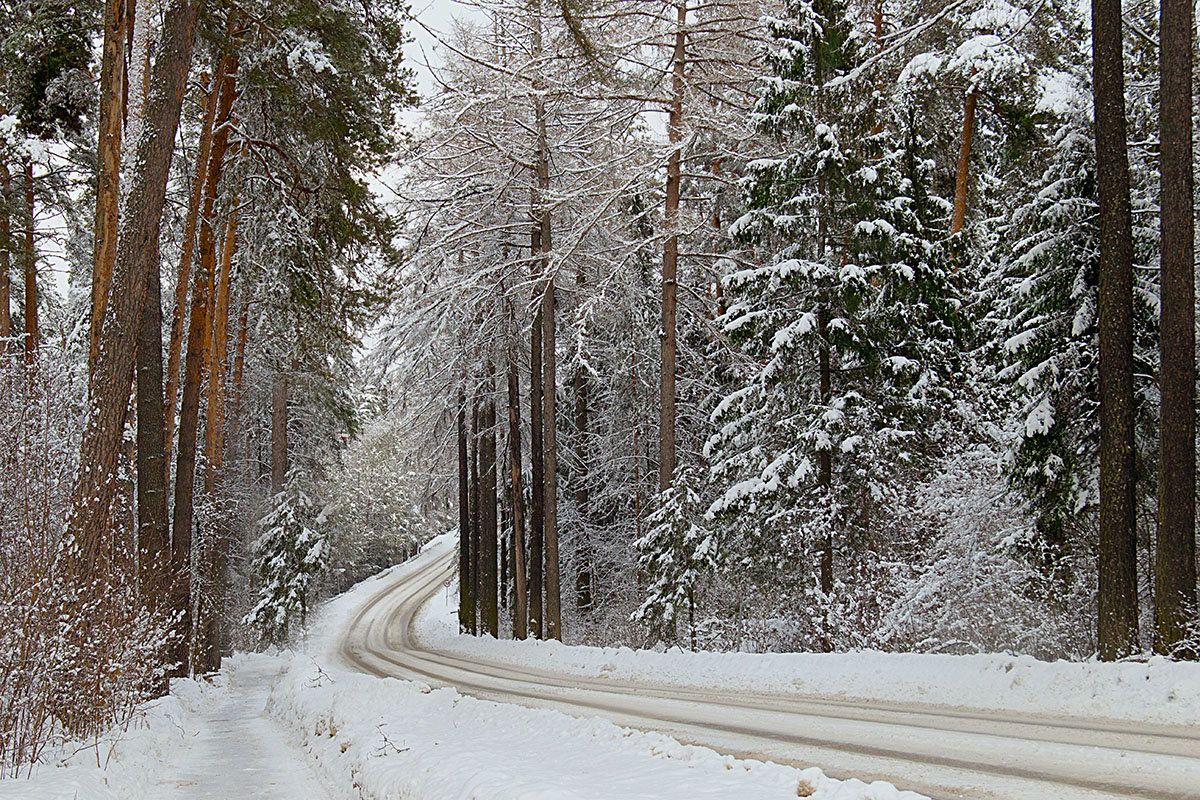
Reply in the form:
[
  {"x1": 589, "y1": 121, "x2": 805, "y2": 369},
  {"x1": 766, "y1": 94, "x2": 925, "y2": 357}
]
[{"x1": 1092, "y1": 0, "x2": 1139, "y2": 661}]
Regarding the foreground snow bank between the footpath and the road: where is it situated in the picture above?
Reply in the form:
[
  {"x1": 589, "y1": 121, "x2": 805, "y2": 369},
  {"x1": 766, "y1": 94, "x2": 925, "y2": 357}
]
[{"x1": 268, "y1": 657, "x2": 920, "y2": 800}]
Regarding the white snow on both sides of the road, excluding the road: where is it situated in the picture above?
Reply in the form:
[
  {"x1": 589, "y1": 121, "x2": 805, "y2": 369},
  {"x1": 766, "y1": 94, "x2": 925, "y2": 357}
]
[{"x1": 7, "y1": 537, "x2": 1200, "y2": 800}]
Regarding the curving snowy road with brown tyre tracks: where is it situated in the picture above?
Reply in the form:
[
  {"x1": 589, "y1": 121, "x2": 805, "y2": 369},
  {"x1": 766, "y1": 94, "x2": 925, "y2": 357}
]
[{"x1": 341, "y1": 549, "x2": 1200, "y2": 800}]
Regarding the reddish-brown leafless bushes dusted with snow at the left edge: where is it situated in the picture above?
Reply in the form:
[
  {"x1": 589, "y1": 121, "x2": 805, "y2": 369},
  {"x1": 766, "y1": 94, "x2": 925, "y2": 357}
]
[{"x1": 0, "y1": 349, "x2": 170, "y2": 776}]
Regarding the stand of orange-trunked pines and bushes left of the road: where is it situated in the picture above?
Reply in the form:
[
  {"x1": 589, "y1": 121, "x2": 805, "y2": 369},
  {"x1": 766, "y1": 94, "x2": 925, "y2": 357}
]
[{"x1": 0, "y1": 0, "x2": 422, "y2": 770}]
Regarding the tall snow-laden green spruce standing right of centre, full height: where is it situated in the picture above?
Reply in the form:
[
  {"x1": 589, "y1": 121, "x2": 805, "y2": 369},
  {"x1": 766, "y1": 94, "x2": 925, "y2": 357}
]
[{"x1": 706, "y1": 5, "x2": 960, "y2": 648}]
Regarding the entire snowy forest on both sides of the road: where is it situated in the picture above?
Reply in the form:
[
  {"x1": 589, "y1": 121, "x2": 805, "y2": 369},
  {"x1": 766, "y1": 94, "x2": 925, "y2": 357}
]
[{"x1": 0, "y1": 0, "x2": 1200, "y2": 774}]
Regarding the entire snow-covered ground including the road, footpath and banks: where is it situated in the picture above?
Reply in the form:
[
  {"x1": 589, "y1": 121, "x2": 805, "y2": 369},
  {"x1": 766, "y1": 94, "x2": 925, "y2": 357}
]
[{"x1": 7, "y1": 537, "x2": 1200, "y2": 800}]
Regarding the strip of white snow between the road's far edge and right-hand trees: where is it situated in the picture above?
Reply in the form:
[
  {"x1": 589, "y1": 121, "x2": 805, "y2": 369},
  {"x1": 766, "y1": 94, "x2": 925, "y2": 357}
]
[{"x1": 414, "y1": 543, "x2": 1200, "y2": 726}]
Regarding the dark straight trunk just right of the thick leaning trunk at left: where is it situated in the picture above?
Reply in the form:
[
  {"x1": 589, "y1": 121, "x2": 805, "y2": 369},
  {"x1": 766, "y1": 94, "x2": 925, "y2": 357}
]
[{"x1": 137, "y1": 241, "x2": 170, "y2": 609}]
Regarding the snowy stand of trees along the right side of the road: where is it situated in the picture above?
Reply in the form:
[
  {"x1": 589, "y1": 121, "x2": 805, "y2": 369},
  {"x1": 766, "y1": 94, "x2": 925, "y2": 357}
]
[{"x1": 380, "y1": 0, "x2": 1196, "y2": 658}]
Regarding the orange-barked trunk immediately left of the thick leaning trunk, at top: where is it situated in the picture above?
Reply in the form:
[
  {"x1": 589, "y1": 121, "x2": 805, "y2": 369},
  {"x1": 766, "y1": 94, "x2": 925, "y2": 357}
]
[{"x1": 88, "y1": 0, "x2": 128, "y2": 374}]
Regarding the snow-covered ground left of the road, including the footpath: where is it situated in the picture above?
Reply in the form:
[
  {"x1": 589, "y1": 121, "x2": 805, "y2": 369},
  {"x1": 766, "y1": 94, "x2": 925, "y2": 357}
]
[{"x1": 0, "y1": 541, "x2": 919, "y2": 800}]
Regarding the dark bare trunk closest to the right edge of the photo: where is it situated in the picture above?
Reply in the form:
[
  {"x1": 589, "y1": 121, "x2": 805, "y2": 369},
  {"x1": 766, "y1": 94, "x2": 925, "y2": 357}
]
[{"x1": 1154, "y1": 0, "x2": 1198, "y2": 658}]
